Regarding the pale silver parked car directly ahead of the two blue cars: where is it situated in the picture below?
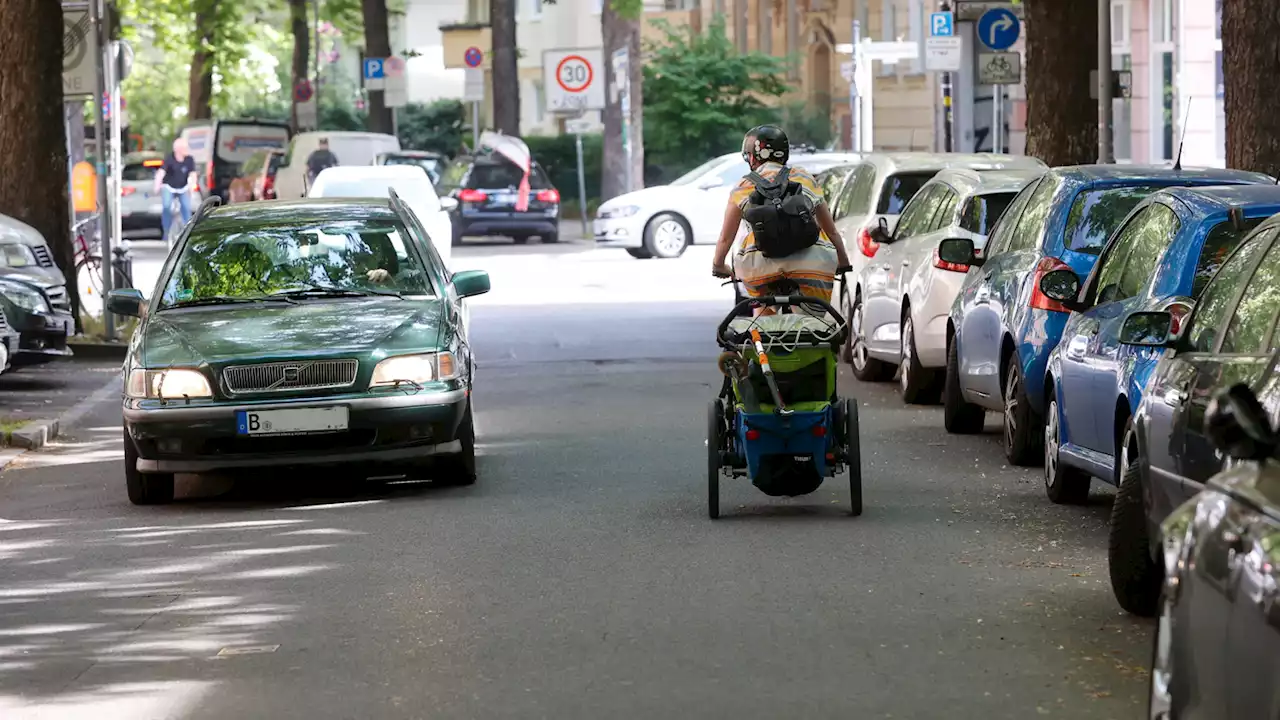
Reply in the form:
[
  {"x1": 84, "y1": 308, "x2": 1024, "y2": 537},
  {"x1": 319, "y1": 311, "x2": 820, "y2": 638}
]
[{"x1": 849, "y1": 168, "x2": 1044, "y2": 404}]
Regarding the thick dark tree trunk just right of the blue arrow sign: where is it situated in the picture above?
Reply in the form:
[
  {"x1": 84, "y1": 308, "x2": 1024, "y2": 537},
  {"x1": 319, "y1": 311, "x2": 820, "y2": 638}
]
[{"x1": 1023, "y1": 0, "x2": 1098, "y2": 167}]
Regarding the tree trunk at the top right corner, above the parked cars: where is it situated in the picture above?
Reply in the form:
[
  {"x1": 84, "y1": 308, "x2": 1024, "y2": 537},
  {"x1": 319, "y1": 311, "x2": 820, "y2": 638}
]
[{"x1": 1222, "y1": 0, "x2": 1280, "y2": 177}]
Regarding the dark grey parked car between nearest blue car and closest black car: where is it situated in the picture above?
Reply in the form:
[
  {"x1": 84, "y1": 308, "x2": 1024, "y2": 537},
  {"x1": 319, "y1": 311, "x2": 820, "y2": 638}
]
[{"x1": 1110, "y1": 210, "x2": 1280, "y2": 615}]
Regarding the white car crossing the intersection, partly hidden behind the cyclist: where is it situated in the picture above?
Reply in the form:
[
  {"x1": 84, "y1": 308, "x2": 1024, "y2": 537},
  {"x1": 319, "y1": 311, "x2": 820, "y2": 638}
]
[{"x1": 593, "y1": 149, "x2": 861, "y2": 259}]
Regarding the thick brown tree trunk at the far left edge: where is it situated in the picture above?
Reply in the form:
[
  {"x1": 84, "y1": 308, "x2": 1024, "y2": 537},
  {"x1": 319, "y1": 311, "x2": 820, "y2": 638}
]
[{"x1": 0, "y1": 0, "x2": 79, "y2": 319}]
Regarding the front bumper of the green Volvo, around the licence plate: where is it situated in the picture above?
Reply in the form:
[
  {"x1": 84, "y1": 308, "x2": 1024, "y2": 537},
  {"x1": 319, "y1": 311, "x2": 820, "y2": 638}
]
[{"x1": 124, "y1": 389, "x2": 470, "y2": 473}]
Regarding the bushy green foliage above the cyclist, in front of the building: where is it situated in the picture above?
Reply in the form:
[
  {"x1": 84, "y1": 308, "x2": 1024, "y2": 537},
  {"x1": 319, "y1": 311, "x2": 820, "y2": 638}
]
[{"x1": 644, "y1": 17, "x2": 786, "y2": 172}]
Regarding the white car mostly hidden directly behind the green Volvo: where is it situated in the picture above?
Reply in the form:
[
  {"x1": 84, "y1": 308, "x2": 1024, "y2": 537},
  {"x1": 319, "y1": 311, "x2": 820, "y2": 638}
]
[{"x1": 307, "y1": 165, "x2": 458, "y2": 268}]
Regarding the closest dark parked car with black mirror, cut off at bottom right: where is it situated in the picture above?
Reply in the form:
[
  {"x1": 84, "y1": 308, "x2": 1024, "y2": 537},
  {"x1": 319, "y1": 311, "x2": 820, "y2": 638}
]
[{"x1": 1147, "y1": 381, "x2": 1280, "y2": 720}]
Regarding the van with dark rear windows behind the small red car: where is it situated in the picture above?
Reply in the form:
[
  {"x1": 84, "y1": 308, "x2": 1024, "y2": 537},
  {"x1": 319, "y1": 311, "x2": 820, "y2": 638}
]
[{"x1": 182, "y1": 118, "x2": 291, "y2": 202}]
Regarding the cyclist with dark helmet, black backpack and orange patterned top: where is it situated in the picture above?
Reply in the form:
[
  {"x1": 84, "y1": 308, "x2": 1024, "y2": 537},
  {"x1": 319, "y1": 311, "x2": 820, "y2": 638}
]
[{"x1": 712, "y1": 126, "x2": 851, "y2": 314}]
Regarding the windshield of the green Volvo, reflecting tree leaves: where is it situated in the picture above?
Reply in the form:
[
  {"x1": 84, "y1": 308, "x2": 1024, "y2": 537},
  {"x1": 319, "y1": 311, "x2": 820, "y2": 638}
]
[{"x1": 160, "y1": 218, "x2": 433, "y2": 304}]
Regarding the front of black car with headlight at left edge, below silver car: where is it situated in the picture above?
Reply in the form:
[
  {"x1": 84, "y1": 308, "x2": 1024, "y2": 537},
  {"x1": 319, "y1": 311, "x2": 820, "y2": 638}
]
[{"x1": 0, "y1": 268, "x2": 76, "y2": 368}]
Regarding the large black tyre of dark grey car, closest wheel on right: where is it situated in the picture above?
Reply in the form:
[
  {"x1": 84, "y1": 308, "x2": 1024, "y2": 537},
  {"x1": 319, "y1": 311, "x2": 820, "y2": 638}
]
[{"x1": 1107, "y1": 418, "x2": 1165, "y2": 618}]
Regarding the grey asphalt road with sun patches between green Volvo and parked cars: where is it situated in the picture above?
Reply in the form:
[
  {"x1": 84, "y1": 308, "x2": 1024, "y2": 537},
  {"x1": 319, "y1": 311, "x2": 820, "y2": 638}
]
[{"x1": 0, "y1": 235, "x2": 1151, "y2": 720}]
